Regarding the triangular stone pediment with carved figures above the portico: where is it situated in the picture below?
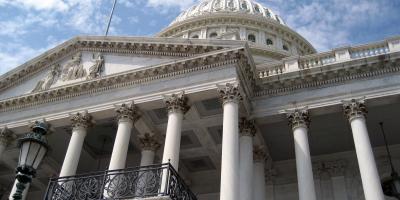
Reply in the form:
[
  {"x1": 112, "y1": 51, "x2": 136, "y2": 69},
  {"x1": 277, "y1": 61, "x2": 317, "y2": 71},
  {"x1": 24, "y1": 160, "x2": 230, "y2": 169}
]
[{"x1": 0, "y1": 37, "x2": 247, "y2": 100}]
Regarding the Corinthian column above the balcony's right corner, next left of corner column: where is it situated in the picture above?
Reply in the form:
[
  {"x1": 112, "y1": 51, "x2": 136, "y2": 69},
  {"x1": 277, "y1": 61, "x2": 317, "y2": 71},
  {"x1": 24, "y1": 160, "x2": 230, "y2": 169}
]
[{"x1": 162, "y1": 92, "x2": 189, "y2": 171}]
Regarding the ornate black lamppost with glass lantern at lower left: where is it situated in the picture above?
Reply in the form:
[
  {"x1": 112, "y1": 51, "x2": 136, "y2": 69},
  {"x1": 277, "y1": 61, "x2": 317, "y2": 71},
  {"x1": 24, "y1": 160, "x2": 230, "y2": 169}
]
[{"x1": 12, "y1": 121, "x2": 49, "y2": 200}]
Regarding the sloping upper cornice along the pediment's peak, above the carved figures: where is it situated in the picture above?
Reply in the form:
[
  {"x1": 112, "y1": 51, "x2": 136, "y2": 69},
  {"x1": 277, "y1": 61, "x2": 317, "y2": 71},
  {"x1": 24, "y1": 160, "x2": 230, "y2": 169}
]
[{"x1": 0, "y1": 36, "x2": 247, "y2": 92}]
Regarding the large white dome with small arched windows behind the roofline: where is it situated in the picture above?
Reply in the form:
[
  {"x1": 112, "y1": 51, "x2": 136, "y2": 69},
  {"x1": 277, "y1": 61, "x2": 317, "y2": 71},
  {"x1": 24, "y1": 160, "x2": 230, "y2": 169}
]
[{"x1": 156, "y1": 0, "x2": 316, "y2": 58}]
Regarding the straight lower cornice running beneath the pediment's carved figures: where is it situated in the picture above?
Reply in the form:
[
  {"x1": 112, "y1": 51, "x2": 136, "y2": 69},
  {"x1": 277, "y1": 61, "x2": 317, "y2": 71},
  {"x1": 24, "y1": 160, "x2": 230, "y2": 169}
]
[{"x1": 0, "y1": 47, "x2": 246, "y2": 112}]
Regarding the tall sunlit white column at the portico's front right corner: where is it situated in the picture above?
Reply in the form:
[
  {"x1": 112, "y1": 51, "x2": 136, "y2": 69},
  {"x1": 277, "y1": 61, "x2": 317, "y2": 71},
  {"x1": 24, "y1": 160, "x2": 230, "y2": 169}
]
[{"x1": 218, "y1": 83, "x2": 242, "y2": 200}]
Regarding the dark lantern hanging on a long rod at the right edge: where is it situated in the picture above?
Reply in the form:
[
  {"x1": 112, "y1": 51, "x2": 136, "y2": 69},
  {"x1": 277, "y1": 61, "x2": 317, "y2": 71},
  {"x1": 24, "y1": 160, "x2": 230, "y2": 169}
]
[{"x1": 379, "y1": 122, "x2": 400, "y2": 199}]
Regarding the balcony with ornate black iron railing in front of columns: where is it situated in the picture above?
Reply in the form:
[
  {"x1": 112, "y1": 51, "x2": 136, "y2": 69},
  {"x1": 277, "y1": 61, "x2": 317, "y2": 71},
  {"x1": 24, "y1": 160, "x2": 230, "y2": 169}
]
[{"x1": 44, "y1": 164, "x2": 197, "y2": 200}]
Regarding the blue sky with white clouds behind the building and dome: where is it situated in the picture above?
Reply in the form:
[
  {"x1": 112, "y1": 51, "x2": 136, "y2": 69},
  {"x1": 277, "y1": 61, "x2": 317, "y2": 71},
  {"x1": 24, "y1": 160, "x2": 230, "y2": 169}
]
[{"x1": 0, "y1": 0, "x2": 400, "y2": 74}]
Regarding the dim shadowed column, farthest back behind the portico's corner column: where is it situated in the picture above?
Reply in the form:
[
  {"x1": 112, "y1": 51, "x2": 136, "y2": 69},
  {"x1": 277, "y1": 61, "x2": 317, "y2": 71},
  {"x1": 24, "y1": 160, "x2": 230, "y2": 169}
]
[{"x1": 253, "y1": 148, "x2": 267, "y2": 200}]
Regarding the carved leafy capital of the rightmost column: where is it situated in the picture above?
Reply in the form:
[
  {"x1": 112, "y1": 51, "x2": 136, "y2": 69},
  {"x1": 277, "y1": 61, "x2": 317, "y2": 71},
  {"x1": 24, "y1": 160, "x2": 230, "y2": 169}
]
[{"x1": 343, "y1": 99, "x2": 368, "y2": 121}]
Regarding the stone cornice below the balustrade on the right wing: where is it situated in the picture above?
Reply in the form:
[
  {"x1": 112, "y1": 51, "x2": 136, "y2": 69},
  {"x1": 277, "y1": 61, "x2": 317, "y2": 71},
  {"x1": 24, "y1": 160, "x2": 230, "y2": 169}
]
[{"x1": 254, "y1": 55, "x2": 400, "y2": 97}]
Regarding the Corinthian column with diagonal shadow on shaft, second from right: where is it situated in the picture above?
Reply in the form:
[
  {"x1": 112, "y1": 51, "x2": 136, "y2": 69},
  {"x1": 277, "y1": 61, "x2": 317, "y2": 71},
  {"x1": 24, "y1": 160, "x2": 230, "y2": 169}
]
[{"x1": 288, "y1": 110, "x2": 316, "y2": 200}]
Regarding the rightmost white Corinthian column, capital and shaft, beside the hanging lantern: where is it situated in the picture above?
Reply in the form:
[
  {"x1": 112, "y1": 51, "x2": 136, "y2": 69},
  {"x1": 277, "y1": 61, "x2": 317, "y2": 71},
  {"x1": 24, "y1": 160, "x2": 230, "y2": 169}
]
[{"x1": 343, "y1": 99, "x2": 384, "y2": 200}]
